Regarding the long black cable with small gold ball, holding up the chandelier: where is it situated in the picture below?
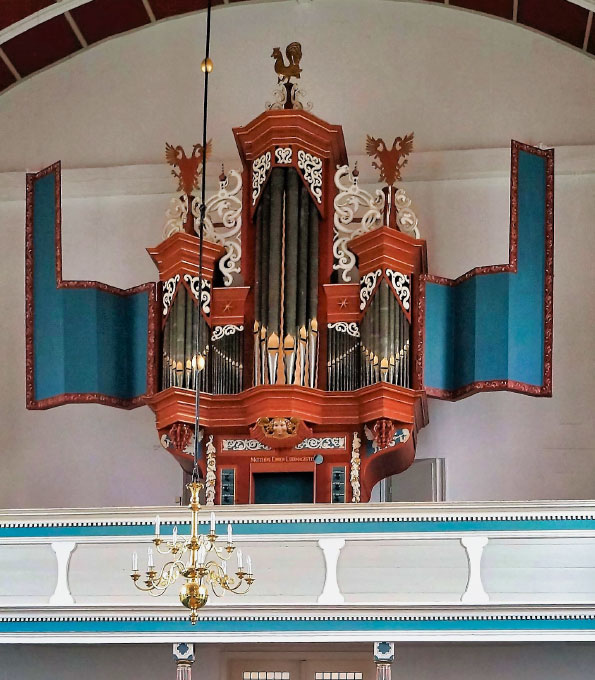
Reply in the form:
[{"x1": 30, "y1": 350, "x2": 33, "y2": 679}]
[{"x1": 192, "y1": 0, "x2": 211, "y2": 482}]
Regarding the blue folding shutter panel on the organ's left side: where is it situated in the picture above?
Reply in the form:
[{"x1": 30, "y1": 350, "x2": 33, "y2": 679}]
[{"x1": 32, "y1": 172, "x2": 151, "y2": 401}]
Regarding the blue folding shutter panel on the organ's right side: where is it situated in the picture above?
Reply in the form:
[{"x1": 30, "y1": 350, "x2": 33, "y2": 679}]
[{"x1": 424, "y1": 150, "x2": 547, "y2": 391}]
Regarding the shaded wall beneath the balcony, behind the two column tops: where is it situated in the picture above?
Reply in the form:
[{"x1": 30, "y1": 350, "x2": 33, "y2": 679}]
[{"x1": 0, "y1": 643, "x2": 595, "y2": 680}]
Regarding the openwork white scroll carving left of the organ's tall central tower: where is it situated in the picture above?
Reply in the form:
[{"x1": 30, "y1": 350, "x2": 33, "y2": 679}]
[{"x1": 192, "y1": 170, "x2": 242, "y2": 286}]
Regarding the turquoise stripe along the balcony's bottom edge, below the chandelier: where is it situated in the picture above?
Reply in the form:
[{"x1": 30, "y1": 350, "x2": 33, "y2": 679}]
[{"x1": 0, "y1": 617, "x2": 595, "y2": 635}]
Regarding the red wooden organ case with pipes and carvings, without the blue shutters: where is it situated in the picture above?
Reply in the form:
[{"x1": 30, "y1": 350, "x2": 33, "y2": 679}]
[{"x1": 147, "y1": 84, "x2": 427, "y2": 504}]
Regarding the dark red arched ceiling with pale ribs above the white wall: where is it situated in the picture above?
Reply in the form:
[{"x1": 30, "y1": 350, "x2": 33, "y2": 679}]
[{"x1": 0, "y1": 0, "x2": 595, "y2": 91}]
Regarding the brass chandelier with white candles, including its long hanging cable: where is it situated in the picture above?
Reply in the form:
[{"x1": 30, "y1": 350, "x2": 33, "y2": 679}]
[{"x1": 130, "y1": 0, "x2": 254, "y2": 625}]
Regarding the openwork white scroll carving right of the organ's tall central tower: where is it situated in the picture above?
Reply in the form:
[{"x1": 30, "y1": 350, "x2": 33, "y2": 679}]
[{"x1": 333, "y1": 165, "x2": 384, "y2": 283}]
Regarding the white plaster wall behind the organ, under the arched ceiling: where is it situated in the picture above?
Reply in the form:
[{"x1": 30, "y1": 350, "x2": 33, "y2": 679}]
[{"x1": 0, "y1": 0, "x2": 595, "y2": 507}]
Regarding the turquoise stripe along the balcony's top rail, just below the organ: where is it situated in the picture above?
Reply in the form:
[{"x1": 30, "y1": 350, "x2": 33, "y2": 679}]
[{"x1": 0, "y1": 519, "x2": 595, "y2": 538}]
